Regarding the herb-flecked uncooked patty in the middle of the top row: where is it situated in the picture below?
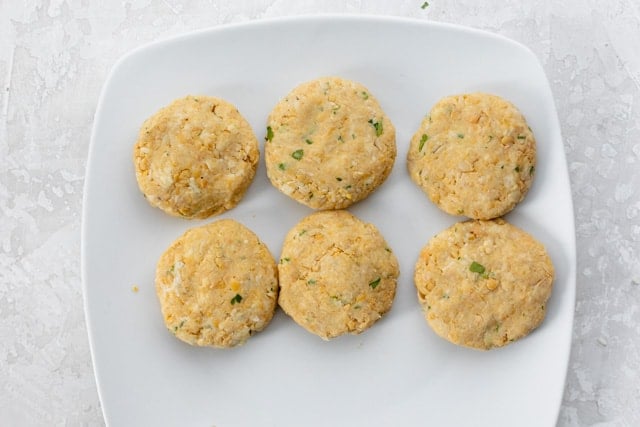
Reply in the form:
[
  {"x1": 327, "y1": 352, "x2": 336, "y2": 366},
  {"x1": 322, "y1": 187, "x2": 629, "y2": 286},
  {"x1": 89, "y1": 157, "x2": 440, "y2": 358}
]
[{"x1": 265, "y1": 77, "x2": 396, "y2": 209}]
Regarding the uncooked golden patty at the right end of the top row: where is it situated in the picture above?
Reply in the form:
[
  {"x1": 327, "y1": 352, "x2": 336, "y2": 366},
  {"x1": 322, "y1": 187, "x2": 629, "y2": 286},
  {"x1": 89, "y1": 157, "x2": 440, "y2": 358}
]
[{"x1": 407, "y1": 93, "x2": 536, "y2": 219}]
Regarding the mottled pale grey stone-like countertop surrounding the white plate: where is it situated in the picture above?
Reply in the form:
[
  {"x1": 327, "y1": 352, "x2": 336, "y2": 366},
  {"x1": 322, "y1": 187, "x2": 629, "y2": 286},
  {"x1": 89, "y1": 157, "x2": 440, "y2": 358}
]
[{"x1": 0, "y1": 0, "x2": 640, "y2": 426}]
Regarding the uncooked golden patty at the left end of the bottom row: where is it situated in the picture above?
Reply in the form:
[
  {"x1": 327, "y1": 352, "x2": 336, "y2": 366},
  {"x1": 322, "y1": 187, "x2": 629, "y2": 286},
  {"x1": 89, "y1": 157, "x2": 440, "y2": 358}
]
[{"x1": 156, "y1": 219, "x2": 278, "y2": 348}]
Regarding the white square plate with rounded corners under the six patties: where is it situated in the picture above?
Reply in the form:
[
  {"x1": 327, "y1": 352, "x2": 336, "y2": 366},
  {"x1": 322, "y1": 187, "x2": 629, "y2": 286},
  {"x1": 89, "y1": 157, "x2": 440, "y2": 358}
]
[{"x1": 82, "y1": 16, "x2": 575, "y2": 427}]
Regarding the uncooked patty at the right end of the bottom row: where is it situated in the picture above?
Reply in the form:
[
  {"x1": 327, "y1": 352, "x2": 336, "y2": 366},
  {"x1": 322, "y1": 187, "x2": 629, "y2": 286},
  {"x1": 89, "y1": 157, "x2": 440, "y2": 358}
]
[{"x1": 414, "y1": 219, "x2": 554, "y2": 350}]
